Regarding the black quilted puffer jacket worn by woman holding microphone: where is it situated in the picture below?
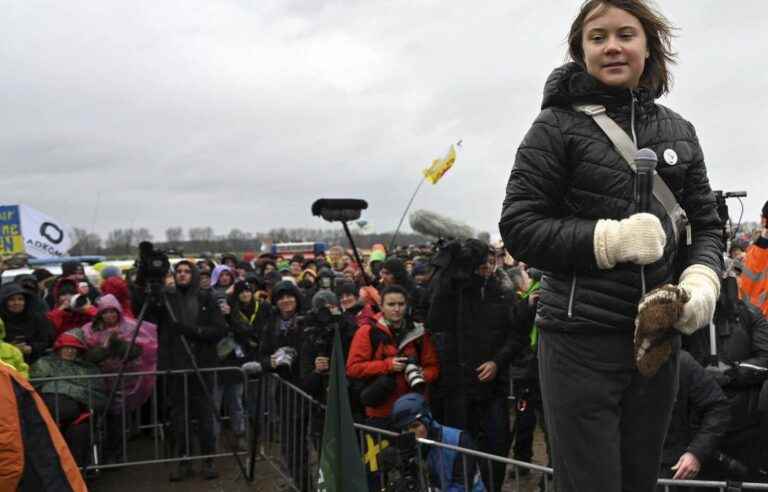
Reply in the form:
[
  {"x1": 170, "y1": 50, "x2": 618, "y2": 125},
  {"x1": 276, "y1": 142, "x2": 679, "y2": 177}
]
[{"x1": 499, "y1": 63, "x2": 722, "y2": 333}]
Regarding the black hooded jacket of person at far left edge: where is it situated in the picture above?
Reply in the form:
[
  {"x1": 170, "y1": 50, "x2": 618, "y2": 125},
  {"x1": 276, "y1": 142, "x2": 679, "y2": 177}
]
[{"x1": 0, "y1": 283, "x2": 55, "y2": 364}]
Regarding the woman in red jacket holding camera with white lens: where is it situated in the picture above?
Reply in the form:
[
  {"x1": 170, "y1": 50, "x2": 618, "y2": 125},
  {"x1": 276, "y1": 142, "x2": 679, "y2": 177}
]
[{"x1": 347, "y1": 285, "x2": 439, "y2": 429}]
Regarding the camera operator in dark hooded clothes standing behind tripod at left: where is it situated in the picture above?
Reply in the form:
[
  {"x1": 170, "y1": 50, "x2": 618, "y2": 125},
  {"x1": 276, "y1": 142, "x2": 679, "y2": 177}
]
[{"x1": 137, "y1": 260, "x2": 227, "y2": 481}]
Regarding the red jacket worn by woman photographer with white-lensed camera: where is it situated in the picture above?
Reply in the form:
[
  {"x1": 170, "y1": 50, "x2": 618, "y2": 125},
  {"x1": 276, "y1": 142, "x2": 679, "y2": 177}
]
[{"x1": 347, "y1": 314, "x2": 440, "y2": 417}]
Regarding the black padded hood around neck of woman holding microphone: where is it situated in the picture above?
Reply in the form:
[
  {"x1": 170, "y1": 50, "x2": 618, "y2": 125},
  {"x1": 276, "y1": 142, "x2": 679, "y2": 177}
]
[{"x1": 541, "y1": 62, "x2": 655, "y2": 109}]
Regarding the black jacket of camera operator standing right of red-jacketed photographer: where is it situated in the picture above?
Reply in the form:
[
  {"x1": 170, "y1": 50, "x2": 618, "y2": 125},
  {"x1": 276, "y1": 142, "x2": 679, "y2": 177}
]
[{"x1": 426, "y1": 275, "x2": 530, "y2": 399}]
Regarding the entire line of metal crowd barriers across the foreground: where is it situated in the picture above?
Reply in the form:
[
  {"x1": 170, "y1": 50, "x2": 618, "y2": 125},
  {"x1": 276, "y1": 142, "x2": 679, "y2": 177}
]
[{"x1": 31, "y1": 367, "x2": 768, "y2": 492}]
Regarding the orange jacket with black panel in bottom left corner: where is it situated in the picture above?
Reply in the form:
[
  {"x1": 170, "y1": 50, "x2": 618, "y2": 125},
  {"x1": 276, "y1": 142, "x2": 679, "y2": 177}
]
[{"x1": 0, "y1": 364, "x2": 88, "y2": 492}]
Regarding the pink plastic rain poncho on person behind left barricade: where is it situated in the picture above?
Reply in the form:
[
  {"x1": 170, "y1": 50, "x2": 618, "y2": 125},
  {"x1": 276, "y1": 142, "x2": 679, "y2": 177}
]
[{"x1": 83, "y1": 294, "x2": 157, "y2": 413}]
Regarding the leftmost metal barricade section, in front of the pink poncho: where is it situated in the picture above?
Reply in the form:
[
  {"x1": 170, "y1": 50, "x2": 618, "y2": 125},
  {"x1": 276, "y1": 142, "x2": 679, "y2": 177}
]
[{"x1": 30, "y1": 367, "x2": 252, "y2": 476}]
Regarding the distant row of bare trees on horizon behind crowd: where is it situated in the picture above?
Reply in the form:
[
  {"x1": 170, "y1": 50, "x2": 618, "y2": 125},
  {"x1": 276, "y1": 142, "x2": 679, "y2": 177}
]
[{"x1": 69, "y1": 227, "x2": 431, "y2": 256}]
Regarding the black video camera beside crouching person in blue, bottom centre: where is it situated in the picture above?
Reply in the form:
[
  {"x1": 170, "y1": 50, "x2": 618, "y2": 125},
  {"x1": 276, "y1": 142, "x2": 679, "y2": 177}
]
[{"x1": 380, "y1": 432, "x2": 426, "y2": 492}]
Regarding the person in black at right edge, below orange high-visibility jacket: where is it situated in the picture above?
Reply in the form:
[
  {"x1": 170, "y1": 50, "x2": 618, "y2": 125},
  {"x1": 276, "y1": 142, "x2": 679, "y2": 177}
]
[{"x1": 684, "y1": 263, "x2": 768, "y2": 480}]
